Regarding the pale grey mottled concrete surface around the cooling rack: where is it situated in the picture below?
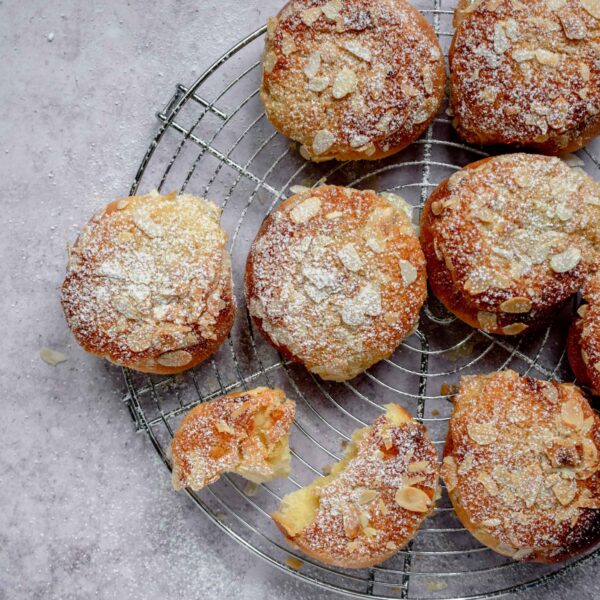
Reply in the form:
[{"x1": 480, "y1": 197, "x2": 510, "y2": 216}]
[{"x1": 0, "y1": 0, "x2": 600, "y2": 600}]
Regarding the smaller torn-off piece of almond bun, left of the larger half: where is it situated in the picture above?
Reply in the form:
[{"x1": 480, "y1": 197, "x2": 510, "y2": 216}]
[{"x1": 170, "y1": 387, "x2": 296, "y2": 490}]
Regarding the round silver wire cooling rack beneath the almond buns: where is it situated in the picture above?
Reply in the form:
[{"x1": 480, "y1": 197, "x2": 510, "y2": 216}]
[{"x1": 125, "y1": 0, "x2": 600, "y2": 599}]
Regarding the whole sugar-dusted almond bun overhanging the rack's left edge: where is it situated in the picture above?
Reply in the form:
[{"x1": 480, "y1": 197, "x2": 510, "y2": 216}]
[{"x1": 62, "y1": 193, "x2": 235, "y2": 375}]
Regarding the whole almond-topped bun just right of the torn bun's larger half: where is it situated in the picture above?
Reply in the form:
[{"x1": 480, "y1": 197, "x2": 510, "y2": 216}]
[{"x1": 442, "y1": 371, "x2": 600, "y2": 563}]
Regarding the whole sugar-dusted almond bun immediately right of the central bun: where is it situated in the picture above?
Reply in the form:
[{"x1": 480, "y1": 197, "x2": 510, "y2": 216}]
[{"x1": 421, "y1": 154, "x2": 600, "y2": 335}]
